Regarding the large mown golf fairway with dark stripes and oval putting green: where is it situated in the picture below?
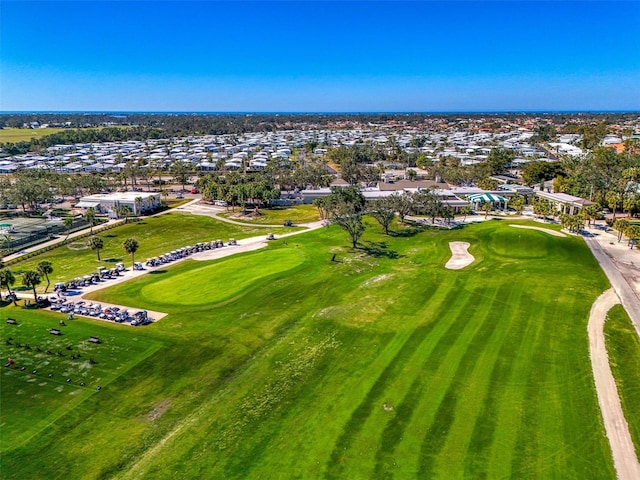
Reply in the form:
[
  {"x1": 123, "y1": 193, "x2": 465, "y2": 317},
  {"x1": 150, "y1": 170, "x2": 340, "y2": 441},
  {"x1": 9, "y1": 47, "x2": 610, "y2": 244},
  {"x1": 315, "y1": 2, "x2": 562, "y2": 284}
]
[{"x1": 0, "y1": 221, "x2": 615, "y2": 480}]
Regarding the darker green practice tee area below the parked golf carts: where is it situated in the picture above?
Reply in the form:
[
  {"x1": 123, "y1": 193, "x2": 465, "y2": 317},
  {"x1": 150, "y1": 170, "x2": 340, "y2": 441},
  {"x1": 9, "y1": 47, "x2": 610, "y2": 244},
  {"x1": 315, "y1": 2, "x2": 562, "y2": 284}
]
[{"x1": 0, "y1": 307, "x2": 161, "y2": 450}]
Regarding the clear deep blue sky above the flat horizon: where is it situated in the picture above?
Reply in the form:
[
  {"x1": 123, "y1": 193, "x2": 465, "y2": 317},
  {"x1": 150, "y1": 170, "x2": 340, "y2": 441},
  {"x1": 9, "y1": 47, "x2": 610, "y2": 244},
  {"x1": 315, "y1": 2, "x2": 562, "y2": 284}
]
[{"x1": 0, "y1": 0, "x2": 640, "y2": 112}]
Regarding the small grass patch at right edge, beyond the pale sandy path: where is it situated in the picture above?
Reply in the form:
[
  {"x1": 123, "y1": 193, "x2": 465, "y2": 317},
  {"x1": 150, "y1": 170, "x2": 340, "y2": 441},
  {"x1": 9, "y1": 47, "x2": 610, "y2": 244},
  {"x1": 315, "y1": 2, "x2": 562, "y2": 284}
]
[{"x1": 604, "y1": 305, "x2": 640, "y2": 457}]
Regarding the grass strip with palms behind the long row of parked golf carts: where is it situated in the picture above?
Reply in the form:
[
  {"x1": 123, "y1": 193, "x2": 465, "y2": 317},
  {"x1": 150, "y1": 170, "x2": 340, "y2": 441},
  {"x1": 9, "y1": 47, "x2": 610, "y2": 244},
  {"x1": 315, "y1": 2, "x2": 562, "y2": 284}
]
[{"x1": 10, "y1": 213, "x2": 300, "y2": 291}]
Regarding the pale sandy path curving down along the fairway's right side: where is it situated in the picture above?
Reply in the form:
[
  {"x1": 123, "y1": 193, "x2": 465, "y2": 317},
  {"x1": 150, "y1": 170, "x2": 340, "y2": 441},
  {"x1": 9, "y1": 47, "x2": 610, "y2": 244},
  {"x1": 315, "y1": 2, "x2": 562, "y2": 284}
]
[{"x1": 587, "y1": 288, "x2": 640, "y2": 480}]
